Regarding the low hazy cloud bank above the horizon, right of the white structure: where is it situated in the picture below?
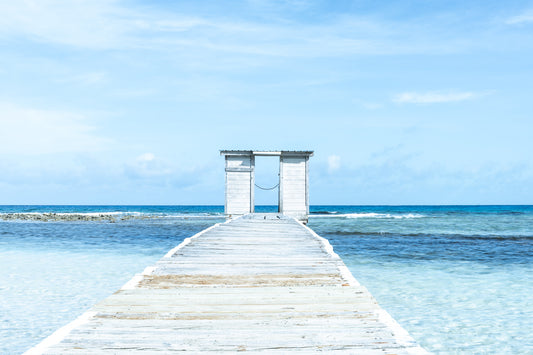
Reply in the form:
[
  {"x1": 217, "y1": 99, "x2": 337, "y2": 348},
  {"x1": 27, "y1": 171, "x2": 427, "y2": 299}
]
[{"x1": 313, "y1": 153, "x2": 533, "y2": 205}]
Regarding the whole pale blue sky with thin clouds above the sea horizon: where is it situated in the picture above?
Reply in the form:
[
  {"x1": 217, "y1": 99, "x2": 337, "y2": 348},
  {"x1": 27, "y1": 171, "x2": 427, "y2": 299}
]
[{"x1": 0, "y1": 0, "x2": 533, "y2": 204}]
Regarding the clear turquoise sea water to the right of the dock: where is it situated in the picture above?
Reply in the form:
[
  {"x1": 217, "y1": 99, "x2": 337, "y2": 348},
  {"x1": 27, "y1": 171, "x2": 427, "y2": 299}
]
[{"x1": 309, "y1": 206, "x2": 533, "y2": 354}]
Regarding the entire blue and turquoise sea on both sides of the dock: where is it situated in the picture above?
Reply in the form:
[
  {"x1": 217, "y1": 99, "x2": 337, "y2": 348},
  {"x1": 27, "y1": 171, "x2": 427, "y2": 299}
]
[{"x1": 0, "y1": 206, "x2": 533, "y2": 354}]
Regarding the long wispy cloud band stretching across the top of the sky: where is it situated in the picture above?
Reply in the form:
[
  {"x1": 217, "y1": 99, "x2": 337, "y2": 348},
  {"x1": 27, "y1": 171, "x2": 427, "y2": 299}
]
[{"x1": 0, "y1": 0, "x2": 482, "y2": 58}]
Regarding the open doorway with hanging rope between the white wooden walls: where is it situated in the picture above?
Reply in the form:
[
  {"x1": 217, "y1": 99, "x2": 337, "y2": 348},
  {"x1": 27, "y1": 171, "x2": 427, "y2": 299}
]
[{"x1": 253, "y1": 156, "x2": 280, "y2": 212}]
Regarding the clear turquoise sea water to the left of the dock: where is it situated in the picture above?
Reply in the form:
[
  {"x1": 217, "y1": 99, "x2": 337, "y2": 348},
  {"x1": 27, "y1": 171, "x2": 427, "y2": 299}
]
[{"x1": 0, "y1": 206, "x2": 224, "y2": 354}]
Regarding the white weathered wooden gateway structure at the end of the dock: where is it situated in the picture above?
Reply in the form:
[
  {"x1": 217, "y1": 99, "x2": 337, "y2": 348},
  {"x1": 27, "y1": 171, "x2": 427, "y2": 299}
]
[{"x1": 220, "y1": 150, "x2": 313, "y2": 223}]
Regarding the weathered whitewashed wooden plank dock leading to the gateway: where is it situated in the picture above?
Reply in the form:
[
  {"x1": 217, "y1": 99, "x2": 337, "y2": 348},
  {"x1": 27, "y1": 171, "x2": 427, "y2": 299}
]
[{"x1": 27, "y1": 214, "x2": 427, "y2": 354}]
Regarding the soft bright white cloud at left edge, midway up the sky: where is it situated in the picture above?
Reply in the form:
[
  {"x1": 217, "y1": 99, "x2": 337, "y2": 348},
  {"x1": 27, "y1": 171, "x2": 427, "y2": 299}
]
[{"x1": 0, "y1": 102, "x2": 111, "y2": 155}]
